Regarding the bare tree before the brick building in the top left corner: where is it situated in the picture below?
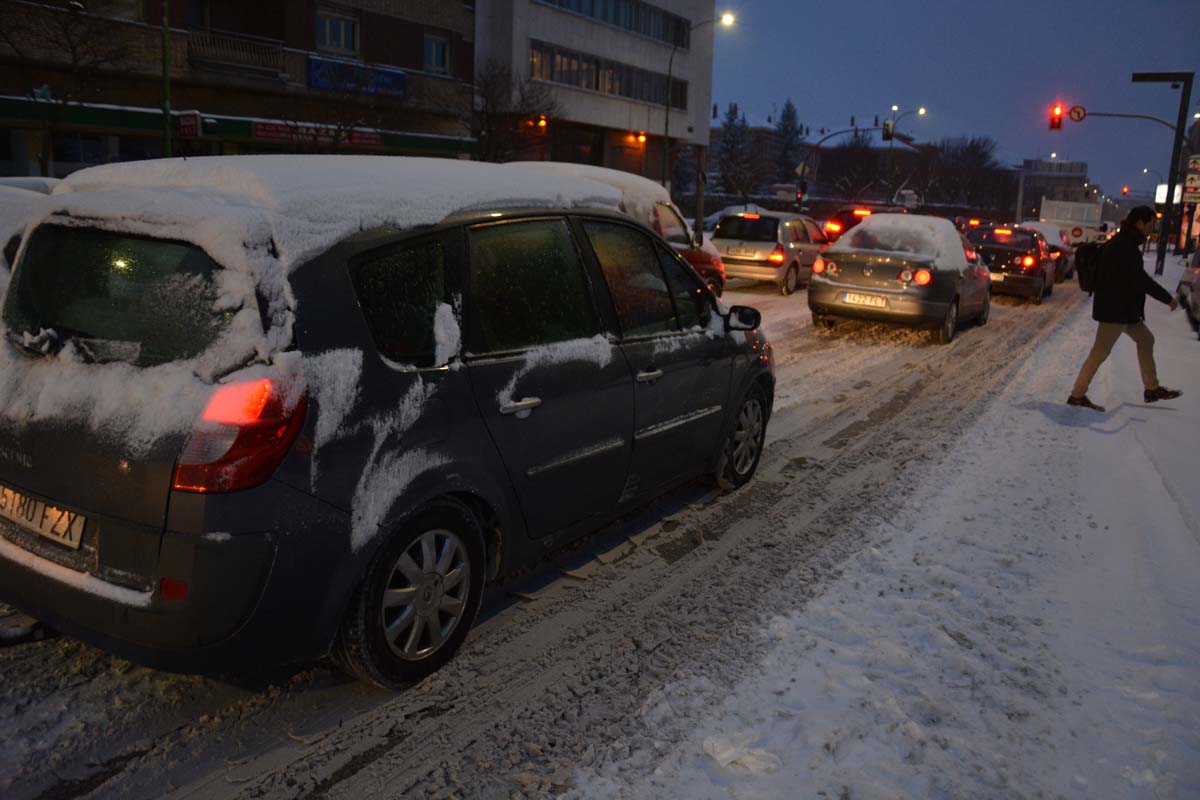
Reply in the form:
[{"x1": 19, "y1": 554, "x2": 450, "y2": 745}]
[{"x1": 0, "y1": 0, "x2": 130, "y2": 175}]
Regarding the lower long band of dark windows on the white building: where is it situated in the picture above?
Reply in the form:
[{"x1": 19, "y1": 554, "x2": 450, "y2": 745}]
[{"x1": 529, "y1": 40, "x2": 688, "y2": 110}]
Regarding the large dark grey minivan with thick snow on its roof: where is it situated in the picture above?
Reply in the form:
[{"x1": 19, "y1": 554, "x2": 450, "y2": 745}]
[{"x1": 0, "y1": 156, "x2": 774, "y2": 687}]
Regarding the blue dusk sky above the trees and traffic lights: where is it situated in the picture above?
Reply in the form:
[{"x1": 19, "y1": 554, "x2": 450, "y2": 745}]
[{"x1": 713, "y1": 0, "x2": 1200, "y2": 199}]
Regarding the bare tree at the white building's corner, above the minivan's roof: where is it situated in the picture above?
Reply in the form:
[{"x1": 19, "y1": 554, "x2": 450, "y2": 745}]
[{"x1": 463, "y1": 60, "x2": 562, "y2": 162}]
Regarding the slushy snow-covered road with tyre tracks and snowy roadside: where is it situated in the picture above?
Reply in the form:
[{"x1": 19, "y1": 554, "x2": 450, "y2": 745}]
[{"x1": 0, "y1": 263, "x2": 1200, "y2": 800}]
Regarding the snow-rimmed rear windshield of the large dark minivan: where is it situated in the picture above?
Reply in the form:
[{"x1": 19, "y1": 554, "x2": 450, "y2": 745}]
[{"x1": 4, "y1": 224, "x2": 233, "y2": 366}]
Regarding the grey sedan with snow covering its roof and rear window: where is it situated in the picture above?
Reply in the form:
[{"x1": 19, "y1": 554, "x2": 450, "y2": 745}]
[{"x1": 809, "y1": 213, "x2": 991, "y2": 344}]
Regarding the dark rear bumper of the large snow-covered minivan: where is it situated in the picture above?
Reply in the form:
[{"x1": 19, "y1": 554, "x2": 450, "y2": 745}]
[{"x1": 0, "y1": 482, "x2": 349, "y2": 673}]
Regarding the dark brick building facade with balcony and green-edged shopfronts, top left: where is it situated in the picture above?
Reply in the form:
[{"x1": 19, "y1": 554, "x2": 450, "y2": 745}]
[{"x1": 0, "y1": 0, "x2": 475, "y2": 176}]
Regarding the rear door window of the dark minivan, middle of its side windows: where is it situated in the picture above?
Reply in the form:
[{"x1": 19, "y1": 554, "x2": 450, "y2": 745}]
[{"x1": 468, "y1": 218, "x2": 599, "y2": 353}]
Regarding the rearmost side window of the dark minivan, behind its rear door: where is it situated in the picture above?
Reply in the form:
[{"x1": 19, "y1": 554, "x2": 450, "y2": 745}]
[{"x1": 350, "y1": 232, "x2": 449, "y2": 367}]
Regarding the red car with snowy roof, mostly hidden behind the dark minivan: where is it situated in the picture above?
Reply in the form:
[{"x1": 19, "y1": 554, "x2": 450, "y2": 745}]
[{"x1": 510, "y1": 161, "x2": 725, "y2": 297}]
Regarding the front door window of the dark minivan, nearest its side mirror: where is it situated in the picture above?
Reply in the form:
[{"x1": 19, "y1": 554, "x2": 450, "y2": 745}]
[{"x1": 583, "y1": 221, "x2": 678, "y2": 337}]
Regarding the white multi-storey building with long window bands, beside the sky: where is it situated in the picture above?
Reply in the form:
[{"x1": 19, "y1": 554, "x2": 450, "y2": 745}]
[{"x1": 475, "y1": 0, "x2": 718, "y2": 191}]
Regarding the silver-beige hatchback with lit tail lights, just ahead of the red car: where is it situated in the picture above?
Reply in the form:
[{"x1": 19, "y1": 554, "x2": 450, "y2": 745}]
[{"x1": 713, "y1": 211, "x2": 829, "y2": 295}]
